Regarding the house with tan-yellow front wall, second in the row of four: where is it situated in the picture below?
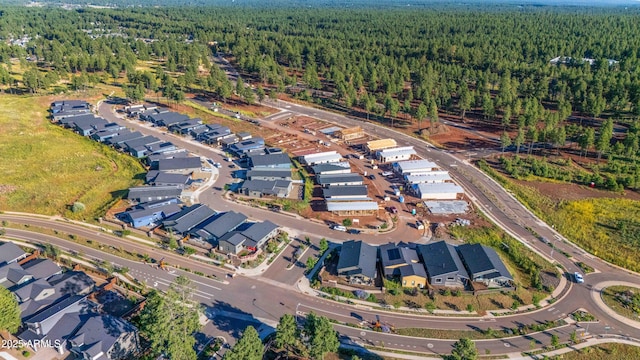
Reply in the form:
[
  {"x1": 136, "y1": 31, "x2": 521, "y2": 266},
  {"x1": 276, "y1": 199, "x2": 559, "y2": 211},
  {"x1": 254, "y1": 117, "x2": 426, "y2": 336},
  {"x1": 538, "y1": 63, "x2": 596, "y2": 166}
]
[{"x1": 378, "y1": 243, "x2": 427, "y2": 289}]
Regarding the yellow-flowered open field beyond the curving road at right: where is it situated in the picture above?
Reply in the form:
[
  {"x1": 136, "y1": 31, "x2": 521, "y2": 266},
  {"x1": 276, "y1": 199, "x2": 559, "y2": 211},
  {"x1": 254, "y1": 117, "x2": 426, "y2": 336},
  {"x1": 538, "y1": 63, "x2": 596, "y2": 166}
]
[{"x1": 479, "y1": 161, "x2": 640, "y2": 271}]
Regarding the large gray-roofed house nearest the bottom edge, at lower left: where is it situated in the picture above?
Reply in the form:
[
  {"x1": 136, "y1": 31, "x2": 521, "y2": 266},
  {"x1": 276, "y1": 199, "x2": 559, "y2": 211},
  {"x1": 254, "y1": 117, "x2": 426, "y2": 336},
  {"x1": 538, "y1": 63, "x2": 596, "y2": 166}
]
[{"x1": 69, "y1": 315, "x2": 140, "y2": 360}]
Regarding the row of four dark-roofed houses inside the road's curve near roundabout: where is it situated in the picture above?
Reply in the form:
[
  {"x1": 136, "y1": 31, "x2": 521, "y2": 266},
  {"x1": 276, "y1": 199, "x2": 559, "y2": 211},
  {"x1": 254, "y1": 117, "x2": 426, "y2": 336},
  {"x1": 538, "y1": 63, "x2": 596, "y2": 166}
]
[{"x1": 337, "y1": 240, "x2": 513, "y2": 288}]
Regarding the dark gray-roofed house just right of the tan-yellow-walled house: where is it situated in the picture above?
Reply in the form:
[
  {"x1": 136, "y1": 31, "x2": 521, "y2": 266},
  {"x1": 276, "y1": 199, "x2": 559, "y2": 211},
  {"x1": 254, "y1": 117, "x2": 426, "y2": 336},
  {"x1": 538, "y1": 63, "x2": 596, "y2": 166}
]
[{"x1": 418, "y1": 241, "x2": 469, "y2": 287}]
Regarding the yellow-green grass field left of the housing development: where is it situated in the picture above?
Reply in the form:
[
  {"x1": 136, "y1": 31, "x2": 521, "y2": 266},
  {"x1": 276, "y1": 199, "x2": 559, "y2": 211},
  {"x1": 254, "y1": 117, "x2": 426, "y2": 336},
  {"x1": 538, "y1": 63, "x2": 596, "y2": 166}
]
[{"x1": 0, "y1": 94, "x2": 144, "y2": 219}]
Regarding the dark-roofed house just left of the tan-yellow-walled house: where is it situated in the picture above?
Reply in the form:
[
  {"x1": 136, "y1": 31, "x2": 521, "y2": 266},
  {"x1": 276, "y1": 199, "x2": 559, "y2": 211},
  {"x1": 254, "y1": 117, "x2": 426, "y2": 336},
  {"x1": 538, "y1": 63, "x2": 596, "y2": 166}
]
[{"x1": 337, "y1": 240, "x2": 378, "y2": 285}]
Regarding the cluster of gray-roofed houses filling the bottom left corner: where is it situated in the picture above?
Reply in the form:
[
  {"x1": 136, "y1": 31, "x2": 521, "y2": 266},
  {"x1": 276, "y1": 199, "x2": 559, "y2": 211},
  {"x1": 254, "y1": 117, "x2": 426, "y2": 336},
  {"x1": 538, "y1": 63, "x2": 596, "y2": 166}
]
[{"x1": 0, "y1": 242, "x2": 140, "y2": 360}]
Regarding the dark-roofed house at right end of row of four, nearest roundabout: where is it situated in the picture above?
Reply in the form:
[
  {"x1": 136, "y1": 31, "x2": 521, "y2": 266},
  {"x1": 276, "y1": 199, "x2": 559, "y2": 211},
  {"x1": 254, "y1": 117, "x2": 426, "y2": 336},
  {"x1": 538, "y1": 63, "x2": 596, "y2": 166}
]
[{"x1": 457, "y1": 244, "x2": 513, "y2": 287}]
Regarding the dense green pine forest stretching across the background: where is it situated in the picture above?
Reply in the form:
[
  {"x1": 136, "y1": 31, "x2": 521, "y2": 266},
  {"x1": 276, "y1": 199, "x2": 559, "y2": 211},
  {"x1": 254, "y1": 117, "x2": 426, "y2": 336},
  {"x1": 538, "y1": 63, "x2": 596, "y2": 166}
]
[{"x1": 0, "y1": 2, "x2": 640, "y2": 188}]
